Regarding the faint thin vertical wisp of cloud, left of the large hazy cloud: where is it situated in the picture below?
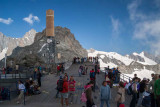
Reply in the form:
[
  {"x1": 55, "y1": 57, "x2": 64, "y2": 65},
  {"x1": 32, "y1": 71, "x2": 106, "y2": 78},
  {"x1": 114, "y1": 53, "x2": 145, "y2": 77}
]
[{"x1": 110, "y1": 16, "x2": 120, "y2": 36}]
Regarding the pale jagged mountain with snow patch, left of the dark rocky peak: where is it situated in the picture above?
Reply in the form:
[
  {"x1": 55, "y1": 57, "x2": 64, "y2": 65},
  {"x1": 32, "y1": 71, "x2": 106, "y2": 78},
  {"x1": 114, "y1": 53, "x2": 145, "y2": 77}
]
[{"x1": 0, "y1": 29, "x2": 36, "y2": 60}]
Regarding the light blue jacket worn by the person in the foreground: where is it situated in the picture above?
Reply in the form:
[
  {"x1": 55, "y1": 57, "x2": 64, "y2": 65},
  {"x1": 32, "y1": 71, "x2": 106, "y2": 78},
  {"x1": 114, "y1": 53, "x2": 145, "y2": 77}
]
[{"x1": 100, "y1": 85, "x2": 111, "y2": 100}]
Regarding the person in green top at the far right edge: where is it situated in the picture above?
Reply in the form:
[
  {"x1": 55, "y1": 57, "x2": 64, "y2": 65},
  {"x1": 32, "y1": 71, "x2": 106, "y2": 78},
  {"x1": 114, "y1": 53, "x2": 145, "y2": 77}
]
[{"x1": 154, "y1": 74, "x2": 160, "y2": 107}]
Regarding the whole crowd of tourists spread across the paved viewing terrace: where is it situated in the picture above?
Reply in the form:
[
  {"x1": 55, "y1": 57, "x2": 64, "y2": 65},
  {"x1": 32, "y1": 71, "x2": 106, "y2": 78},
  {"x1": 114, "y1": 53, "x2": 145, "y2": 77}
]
[{"x1": 3, "y1": 57, "x2": 160, "y2": 107}]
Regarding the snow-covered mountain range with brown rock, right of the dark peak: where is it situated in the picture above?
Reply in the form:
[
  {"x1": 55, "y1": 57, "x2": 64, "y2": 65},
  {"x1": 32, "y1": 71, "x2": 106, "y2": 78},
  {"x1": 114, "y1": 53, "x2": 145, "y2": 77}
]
[{"x1": 88, "y1": 49, "x2": 160, "y2": 78}]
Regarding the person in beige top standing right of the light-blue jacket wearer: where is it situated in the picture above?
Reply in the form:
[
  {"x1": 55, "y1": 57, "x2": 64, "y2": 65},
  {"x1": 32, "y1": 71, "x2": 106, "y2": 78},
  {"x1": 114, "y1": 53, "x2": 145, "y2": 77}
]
[{"x1": 115, "y1": 82, "x2": 125, "y2": 107}]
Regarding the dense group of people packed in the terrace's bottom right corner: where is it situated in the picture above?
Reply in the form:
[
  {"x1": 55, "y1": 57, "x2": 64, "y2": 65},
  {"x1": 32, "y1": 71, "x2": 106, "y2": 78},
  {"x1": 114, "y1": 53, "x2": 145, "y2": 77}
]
[{"x1": 125, "y1": 74, "x2": 160, "y2": 107}]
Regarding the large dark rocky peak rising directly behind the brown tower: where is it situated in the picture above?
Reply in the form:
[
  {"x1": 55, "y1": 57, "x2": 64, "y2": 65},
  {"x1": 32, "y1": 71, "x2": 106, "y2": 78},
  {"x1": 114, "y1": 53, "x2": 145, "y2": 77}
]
[{"x1": 8, "y1": 26, "x2": 87, "y2": 66}]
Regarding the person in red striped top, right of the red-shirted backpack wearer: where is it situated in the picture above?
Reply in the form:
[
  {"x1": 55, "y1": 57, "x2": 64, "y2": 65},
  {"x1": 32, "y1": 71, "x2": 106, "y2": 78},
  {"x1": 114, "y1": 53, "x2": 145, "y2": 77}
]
[{"x1": 69, "y1": 76, "x2": 76, "y2": 104}]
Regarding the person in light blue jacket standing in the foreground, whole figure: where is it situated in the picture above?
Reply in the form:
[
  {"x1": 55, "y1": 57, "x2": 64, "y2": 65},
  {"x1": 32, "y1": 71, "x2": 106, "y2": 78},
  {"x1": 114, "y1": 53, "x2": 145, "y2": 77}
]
[{"x1": 100, "y1": 81, "x2": 111, "y2": 107}]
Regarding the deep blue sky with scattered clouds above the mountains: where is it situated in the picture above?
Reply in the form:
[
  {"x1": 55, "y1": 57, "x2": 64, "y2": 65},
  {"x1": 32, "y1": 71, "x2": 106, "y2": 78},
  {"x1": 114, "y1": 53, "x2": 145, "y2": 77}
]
[{"x1": 0, "y1": 0, "x2": 160, "y2": 55}]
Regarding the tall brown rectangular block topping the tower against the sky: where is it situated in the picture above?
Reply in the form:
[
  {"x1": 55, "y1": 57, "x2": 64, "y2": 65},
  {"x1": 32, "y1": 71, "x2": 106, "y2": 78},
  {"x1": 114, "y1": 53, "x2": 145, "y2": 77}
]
[{"x1": 46, "y1": 9, "x2": 54, "y2": 36}]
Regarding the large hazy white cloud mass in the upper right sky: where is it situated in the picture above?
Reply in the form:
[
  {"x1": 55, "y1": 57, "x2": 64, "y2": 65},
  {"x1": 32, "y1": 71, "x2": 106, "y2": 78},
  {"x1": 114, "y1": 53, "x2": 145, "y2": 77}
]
[{"x1": 128, "y1": 0, "x2": 160, "y2": 55}]
